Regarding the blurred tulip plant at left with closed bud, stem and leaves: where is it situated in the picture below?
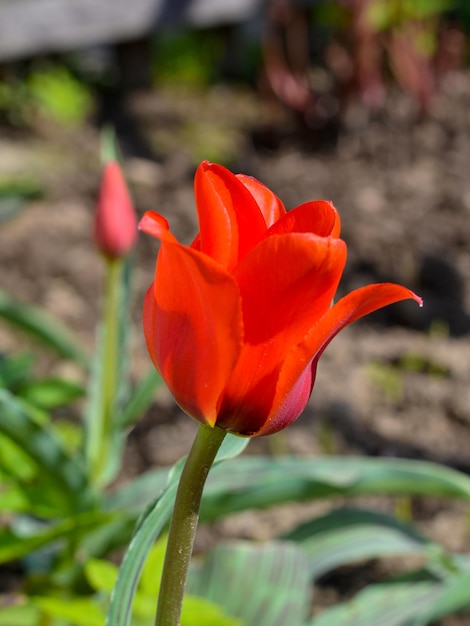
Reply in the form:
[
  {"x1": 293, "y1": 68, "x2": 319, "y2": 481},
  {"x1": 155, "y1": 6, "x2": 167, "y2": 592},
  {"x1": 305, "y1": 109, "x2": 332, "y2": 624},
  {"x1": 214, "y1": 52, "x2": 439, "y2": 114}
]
[{"x1": 0, "y1": 136, "x2": 159, "y2": 624}]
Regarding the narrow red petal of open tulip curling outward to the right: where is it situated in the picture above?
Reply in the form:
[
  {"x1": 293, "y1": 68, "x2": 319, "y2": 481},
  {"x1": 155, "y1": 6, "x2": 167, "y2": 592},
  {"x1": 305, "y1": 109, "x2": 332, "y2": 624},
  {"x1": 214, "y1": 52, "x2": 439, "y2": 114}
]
[{"x1": 257, "y1": 283, "x2": 422, "y2": 435}]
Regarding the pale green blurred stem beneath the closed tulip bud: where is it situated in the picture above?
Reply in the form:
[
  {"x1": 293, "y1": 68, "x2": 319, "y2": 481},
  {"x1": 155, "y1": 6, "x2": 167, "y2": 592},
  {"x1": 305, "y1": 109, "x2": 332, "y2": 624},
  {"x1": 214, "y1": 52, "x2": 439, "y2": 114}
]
[{"x1": 87, "y1": 259, "x2": 124, "y2": 481}]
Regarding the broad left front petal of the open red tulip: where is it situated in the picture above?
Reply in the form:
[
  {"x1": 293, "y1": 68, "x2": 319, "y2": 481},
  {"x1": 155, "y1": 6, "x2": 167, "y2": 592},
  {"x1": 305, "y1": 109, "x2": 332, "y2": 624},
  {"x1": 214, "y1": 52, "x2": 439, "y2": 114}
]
[{"x1": 143, "y1": 240, "x2": 243, "y2": 425}]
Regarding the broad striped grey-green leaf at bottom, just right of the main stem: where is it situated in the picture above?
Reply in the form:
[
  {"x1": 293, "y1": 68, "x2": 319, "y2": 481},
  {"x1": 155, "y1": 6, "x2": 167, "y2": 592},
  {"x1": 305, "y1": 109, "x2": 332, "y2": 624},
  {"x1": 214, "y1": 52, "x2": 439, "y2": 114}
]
[{"x1": 189, "y1": 541, "x2": 311, "y2": 626}]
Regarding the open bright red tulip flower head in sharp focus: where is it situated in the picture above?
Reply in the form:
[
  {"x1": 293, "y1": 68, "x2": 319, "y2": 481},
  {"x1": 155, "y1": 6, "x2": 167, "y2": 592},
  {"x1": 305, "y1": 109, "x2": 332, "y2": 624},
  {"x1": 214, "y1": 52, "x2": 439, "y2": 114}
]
[{"x1": 139, "y1": 162, "x2": 421, "y2": 436}]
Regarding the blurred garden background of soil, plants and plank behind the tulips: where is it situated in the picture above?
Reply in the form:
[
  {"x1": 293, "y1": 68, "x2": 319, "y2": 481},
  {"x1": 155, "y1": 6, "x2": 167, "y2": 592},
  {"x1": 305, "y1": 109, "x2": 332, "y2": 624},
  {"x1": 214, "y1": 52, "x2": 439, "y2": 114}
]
[{"x1": 0, "y1": 0, "x2": 470, "y2": 616}]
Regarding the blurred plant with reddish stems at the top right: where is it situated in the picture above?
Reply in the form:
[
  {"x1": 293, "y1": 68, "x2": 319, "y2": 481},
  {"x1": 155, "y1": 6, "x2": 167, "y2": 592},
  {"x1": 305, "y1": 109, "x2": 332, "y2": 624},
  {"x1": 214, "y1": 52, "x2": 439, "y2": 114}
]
[{"x1": 318, "y1": 0, "x2": 463, "y2": 111}]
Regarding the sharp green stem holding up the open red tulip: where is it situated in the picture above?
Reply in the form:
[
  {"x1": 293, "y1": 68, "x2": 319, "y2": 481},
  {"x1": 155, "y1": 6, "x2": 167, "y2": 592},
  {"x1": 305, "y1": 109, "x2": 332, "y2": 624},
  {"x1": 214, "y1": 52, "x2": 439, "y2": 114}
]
[{"x1": 155, "y1": 426, "x2": 225, "y2": 626}]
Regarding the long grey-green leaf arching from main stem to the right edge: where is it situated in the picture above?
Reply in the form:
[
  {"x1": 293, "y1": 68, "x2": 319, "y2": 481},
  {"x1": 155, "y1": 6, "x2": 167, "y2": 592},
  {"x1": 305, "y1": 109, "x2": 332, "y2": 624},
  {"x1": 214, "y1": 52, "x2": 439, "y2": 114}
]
[{"x1": 201, "y1": 456, "x2": 470, "y2": 520}]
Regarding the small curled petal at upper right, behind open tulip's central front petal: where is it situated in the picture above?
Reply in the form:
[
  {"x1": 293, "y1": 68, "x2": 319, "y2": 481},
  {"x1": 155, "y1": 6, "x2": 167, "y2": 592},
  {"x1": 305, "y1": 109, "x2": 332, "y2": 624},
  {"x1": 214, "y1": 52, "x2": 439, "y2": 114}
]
[{"x1": 268, "y1": 200, "x2": 341, "y2": 237}]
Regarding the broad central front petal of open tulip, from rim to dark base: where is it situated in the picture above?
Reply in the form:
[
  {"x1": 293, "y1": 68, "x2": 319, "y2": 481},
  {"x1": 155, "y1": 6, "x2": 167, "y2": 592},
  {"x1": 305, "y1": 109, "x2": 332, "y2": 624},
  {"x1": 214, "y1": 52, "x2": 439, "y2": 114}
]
[{"x1": 217, "y1": 233, "x2": 346, "y2": 434}]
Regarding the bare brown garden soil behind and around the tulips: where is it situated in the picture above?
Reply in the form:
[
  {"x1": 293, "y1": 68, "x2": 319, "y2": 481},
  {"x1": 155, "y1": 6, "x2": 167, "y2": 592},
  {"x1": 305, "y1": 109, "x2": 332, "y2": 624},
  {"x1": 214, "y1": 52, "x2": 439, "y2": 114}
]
[{"x1": 0, "y1": 73, "x2": 470, "y2": 626}]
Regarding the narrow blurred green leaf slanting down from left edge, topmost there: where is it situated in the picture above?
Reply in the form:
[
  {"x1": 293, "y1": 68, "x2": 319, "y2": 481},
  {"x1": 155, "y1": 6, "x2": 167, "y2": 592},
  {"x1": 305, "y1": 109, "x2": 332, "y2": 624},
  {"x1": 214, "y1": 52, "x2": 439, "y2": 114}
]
[{"x1": 0, "y1": 289, "x2": 88, "y2": 368}]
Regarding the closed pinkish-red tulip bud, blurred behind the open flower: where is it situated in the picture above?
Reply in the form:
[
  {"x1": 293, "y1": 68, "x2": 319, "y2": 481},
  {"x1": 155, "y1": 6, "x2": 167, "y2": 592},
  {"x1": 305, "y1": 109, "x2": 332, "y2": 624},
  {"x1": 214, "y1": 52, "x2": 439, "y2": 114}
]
[{"x1": 94, "y1": 161, "x2": 137, "y2": 259}]
